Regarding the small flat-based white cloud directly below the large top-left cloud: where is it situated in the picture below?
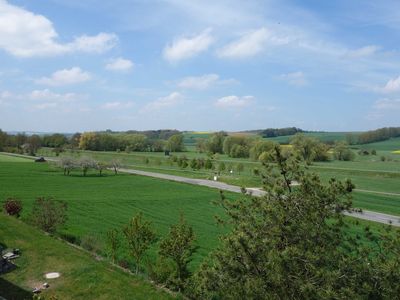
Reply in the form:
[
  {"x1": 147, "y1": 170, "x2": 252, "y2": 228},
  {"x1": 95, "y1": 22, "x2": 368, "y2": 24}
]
[{"x1": 36, "y1": 67, "x2": 91, "y2": 86}]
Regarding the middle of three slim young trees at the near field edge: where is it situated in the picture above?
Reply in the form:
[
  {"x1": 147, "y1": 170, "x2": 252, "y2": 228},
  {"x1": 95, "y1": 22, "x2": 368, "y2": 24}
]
[{"x1": 123, "y1": 213, "x2": 156, "y2": 274}]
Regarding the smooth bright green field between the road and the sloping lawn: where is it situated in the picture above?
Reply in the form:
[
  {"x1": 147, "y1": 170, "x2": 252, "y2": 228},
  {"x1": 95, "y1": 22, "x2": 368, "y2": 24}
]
[{"x1": 0, "y1": 161, "x2": 234, "y2": 265}]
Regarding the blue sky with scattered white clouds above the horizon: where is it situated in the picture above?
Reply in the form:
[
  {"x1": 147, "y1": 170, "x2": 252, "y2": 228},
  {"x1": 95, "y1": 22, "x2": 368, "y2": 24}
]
[{"x1": 0, "y1": 0, "x2": 400, "y2": 132}]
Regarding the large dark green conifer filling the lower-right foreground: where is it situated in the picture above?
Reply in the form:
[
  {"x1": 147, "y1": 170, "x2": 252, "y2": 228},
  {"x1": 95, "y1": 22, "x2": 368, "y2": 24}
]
[{"x1": 192, "y1": 147, "x2": 400, "y2": 299}]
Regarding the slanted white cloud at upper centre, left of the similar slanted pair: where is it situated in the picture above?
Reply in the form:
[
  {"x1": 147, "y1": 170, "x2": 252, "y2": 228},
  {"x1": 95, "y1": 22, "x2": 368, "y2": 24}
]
[{"x1": 163, "y1": 29, "x2": 214, "y2": 62}]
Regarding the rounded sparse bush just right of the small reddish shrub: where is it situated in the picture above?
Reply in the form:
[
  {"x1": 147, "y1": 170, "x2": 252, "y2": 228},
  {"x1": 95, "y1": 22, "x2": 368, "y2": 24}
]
[{"x1": 31, "y1": 197, "x2": 67, "y2": 233}]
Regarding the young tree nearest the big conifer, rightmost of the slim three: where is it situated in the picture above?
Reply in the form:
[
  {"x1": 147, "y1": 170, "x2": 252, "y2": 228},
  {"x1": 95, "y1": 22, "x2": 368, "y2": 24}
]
[{"x1": 159, "y1": 215, "x2": 196, "y2": 291}]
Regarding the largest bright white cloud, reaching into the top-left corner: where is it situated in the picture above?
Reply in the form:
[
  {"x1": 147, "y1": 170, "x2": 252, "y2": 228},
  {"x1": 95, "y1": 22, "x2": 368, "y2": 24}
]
[{"x1": 0, "y1": 0, "x2": 118, "y2": 57}]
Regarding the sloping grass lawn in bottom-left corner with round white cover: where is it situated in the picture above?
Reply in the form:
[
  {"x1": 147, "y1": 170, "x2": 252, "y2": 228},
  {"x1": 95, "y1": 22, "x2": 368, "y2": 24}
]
[{"x1": 0, "y1": 214, "x2": 173, "y2": 300}]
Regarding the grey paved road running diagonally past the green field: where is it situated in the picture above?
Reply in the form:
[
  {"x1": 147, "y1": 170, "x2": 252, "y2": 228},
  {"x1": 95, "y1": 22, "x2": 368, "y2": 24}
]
[{"x1": 120, "y1": 169, "x2": 400, "y2": 227}]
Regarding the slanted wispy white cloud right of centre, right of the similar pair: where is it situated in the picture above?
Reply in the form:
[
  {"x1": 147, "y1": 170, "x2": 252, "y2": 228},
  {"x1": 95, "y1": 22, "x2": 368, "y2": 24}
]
[{"x1": 217, "y1": 27, "x2": 288, "y2": 58}]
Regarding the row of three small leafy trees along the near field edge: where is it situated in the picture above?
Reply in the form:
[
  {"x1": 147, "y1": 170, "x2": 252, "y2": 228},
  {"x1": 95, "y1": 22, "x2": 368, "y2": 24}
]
[{"x1": 106, "y1": 213, "x2": 197, "y2": 291}]
